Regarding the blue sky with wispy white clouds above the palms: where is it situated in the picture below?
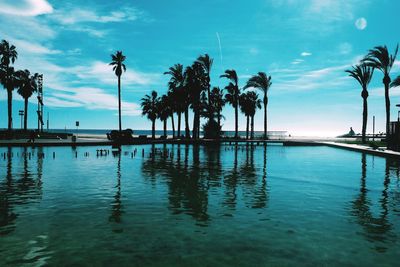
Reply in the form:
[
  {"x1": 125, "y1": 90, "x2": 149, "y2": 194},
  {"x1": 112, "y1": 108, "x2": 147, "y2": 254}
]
[{"x1": 0, "y1": 0, "x2": 400, "y2": 136}]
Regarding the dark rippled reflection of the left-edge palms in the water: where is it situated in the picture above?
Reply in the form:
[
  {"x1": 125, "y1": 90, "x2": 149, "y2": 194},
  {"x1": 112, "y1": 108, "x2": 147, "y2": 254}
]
[{"x1": 0, "y1": 147, "x2": 42, "y2": 238}]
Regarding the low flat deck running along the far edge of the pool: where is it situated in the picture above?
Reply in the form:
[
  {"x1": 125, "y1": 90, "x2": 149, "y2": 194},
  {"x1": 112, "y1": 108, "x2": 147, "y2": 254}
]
[{"x1": 0, "y1": 138, "x2": 400, "y2": 159}]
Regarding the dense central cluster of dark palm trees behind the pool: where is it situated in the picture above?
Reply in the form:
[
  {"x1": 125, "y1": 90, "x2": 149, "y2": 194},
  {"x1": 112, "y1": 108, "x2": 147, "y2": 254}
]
[{"x1": 141, "y1": 54, "x2": 272, "y2": 139}]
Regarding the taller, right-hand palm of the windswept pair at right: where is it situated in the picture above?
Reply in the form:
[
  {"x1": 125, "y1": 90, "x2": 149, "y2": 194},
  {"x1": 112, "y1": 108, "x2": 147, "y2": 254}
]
[{"x1": 362, "y1": 45, "x2": 399, "y2": 134}]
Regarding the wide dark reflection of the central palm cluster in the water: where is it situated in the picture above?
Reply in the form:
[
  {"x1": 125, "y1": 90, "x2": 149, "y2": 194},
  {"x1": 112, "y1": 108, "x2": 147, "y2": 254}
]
[{"x1": 142, "y1": 145, "x2": 268, "y2": 225}]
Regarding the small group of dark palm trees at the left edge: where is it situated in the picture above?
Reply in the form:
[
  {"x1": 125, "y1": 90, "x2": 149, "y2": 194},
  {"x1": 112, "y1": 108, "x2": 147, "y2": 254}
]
[{"x1": 0, "y1": 40, "x2": 39, "y2": 131}]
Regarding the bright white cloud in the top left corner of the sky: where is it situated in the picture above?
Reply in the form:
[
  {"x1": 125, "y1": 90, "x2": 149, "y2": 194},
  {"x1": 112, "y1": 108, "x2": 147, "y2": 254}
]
[{"x1": 0, "y1": 0, "x2": 53, "y2": 17}]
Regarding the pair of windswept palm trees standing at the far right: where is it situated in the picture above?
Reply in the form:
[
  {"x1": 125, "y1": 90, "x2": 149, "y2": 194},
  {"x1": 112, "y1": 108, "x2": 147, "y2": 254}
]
[{"x1": 346, "y1": 45, "x2": 400, "y2": 143}]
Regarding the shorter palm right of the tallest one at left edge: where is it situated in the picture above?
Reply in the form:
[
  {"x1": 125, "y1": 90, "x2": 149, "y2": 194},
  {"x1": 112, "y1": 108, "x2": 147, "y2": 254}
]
[{"x1": 17, "y1": 70, "x2": 39, "y2": 131}]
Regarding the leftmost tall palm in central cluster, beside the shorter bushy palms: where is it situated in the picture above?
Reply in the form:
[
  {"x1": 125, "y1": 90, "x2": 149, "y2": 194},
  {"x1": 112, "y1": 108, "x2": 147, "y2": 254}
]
[{"x1": 164, "y1": 64, "x2": 185, "y2": 137}]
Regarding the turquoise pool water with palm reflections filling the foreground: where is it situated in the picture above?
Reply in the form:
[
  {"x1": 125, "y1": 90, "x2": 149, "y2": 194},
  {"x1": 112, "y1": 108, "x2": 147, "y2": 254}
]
[{"x1": 0, "y1": 145, "x2": 400, "y2": 266}]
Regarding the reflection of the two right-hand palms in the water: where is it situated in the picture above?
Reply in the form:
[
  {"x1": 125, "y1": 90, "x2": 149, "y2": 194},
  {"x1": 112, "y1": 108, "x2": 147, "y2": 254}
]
[{"x1": 352, "y1": 154, "x2": 394, "y2": 251}]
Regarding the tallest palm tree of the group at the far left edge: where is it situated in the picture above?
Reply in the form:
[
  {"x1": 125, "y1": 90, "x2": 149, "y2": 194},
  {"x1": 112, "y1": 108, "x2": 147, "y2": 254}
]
[{"x1": 0, "y1": 40, "x2": 18, "y2": 131}]
